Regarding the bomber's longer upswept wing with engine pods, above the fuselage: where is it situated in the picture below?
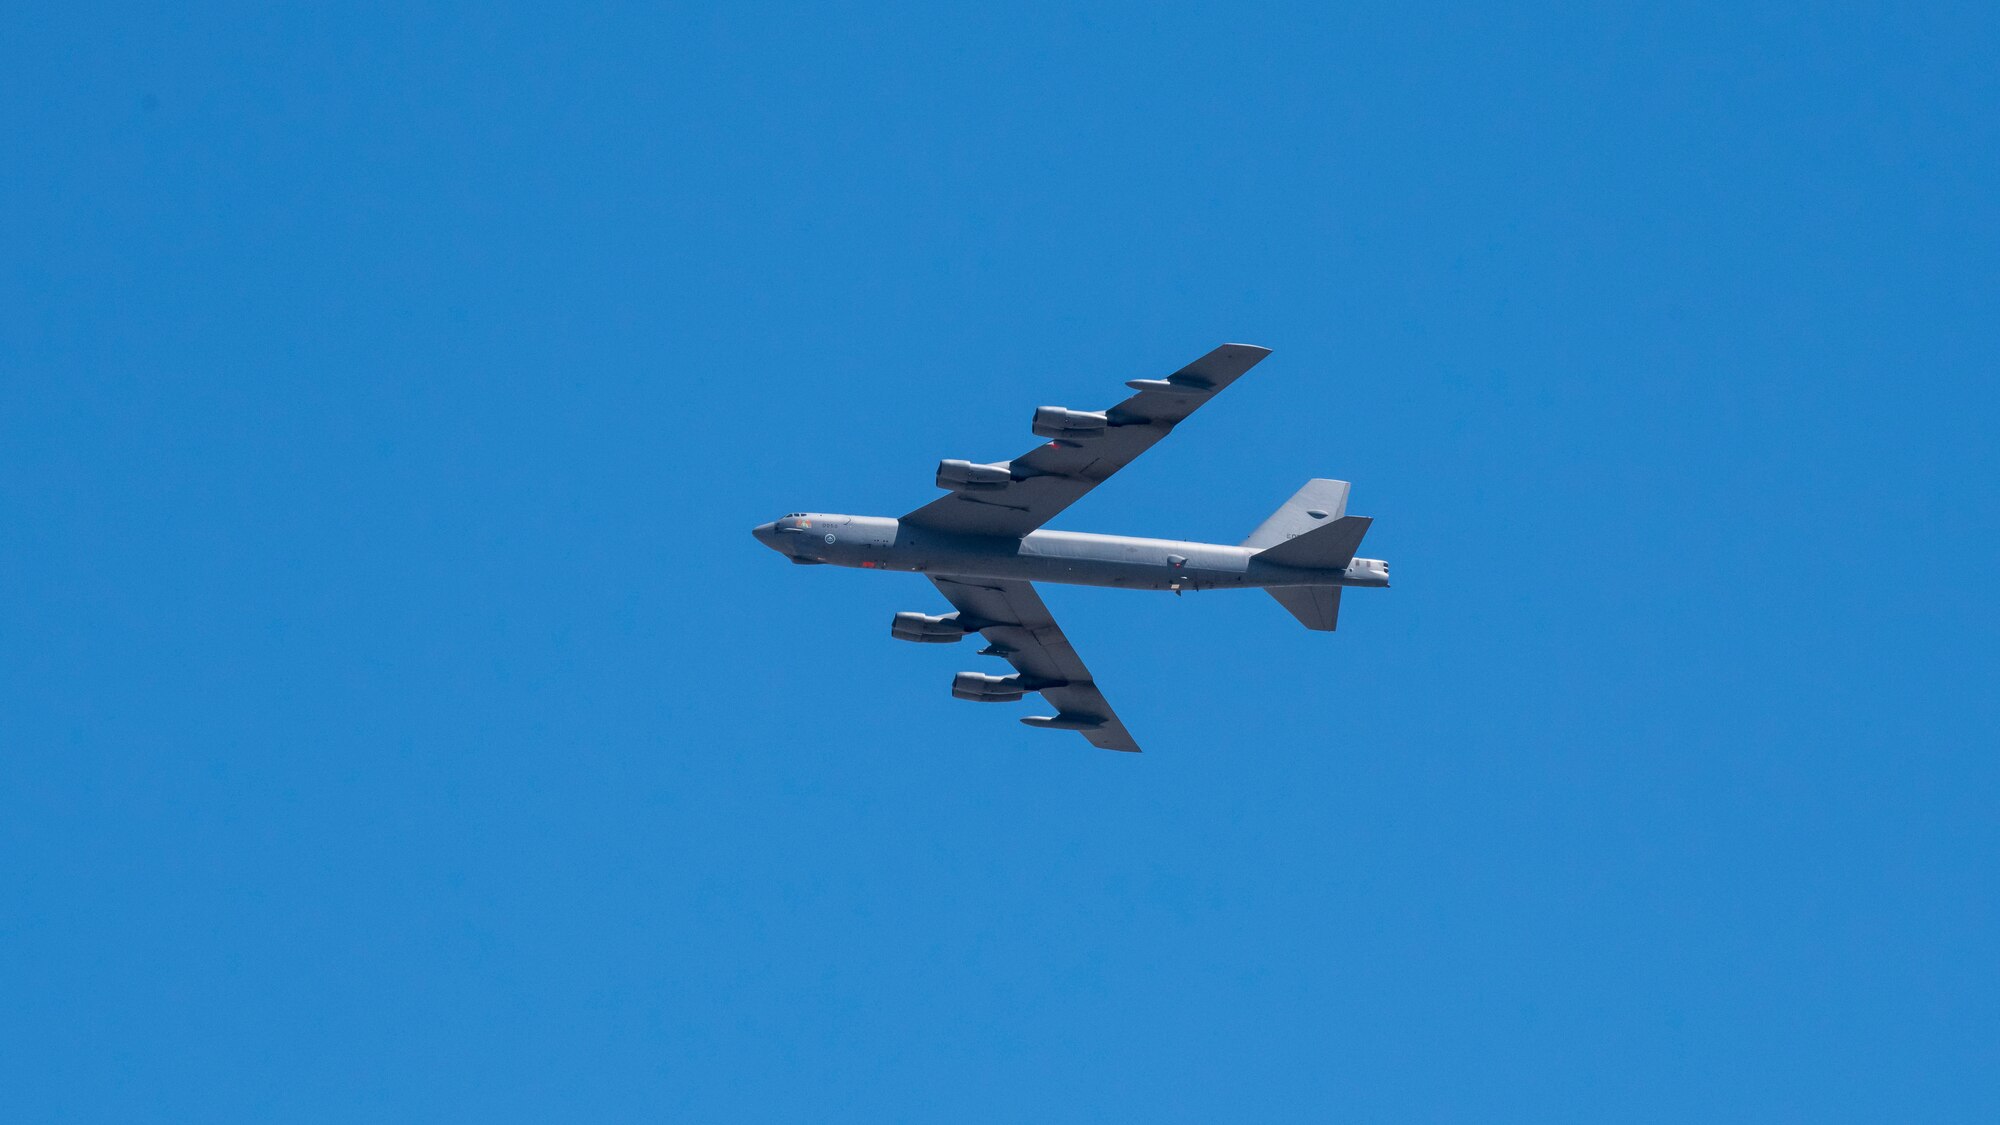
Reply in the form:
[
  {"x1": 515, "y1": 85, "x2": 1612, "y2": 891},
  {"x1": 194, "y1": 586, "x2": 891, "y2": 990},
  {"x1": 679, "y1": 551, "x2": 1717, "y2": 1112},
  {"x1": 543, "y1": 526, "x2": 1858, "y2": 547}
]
[{"x1": 902, "y1": 344, "x2": 1270, "y2": 536}]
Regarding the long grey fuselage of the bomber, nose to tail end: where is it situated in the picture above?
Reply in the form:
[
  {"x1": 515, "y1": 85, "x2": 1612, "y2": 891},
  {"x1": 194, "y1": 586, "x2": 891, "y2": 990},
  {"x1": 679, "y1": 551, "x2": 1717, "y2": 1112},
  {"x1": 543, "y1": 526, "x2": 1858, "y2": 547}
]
[{"x1": 750, "y1": 512, "x2": 1388, "y2": 593}]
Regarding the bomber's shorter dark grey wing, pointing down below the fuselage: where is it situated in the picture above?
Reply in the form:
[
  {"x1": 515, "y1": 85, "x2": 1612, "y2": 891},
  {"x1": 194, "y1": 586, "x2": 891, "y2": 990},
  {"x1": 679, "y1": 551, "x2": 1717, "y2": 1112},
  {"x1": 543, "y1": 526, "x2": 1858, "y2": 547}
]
[{"x1": 930, "y1": 577, "x2": 1138, "y2": 753}]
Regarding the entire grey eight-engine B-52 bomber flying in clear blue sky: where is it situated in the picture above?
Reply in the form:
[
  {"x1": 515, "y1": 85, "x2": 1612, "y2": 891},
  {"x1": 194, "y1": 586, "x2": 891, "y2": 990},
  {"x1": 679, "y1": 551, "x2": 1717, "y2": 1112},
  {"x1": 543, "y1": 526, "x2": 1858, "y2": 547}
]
[{"x1": 752, "y1": 344, "x2": 1388, "y2": 751}]
